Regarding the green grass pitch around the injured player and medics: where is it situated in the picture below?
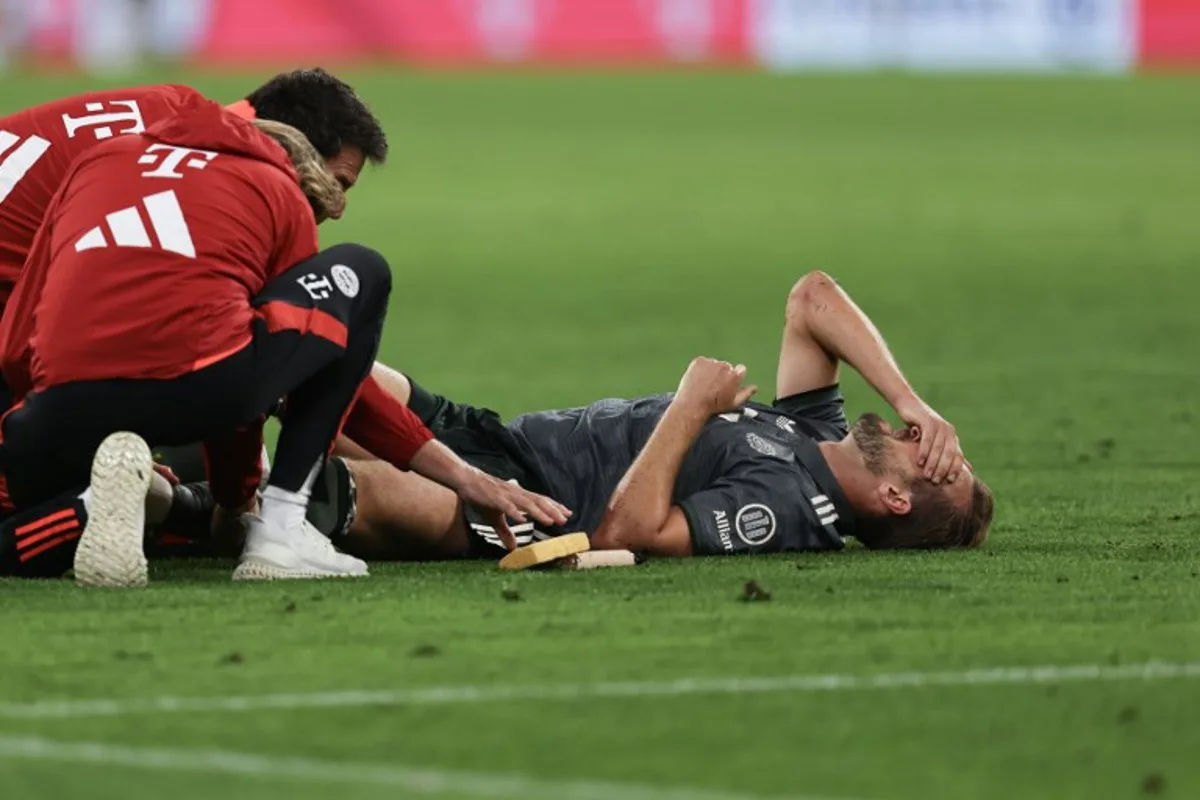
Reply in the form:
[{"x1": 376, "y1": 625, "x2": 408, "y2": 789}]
[{"x1": 0, "y1": 72, "x2": 1200, "y2": 800}]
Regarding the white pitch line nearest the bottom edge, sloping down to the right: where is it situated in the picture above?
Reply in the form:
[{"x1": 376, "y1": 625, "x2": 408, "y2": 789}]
[{"x1": 0, "y1": 736, "x2": 835, "y2": 800}]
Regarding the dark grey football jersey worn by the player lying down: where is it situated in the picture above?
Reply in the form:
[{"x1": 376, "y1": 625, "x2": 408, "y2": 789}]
[{"x1": 508, "y1": 387, "x2": 852, "y2": 554}]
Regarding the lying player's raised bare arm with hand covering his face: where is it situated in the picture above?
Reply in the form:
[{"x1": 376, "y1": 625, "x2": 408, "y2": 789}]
[{"x1": 775, "y1": 271, "x2": 964, "y2": 483}]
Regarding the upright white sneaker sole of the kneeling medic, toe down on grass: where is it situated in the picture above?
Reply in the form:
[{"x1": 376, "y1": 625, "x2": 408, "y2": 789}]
[{"x1": 74, "y1": 433, "x2": 154, "y2": 588}]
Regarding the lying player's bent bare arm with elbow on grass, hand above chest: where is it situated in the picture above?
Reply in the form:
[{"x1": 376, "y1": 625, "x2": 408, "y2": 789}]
[{"x1": 592, "y1": 359, "x2": 756, "y2": 557}]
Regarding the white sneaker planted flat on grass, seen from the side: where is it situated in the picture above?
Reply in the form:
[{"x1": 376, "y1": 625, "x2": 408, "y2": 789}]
[{"x1": 233, "y1": 513, "x2": 367, "y2": 581}]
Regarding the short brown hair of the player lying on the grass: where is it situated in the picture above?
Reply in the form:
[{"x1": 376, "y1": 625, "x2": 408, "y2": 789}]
[{"x1": 854, "y1": 473, "x2": 996, "y2": 551}]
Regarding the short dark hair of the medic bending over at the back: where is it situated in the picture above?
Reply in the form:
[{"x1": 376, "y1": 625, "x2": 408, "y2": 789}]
[{"x1": 246, "y1": 67, "x2": 388, "y2": 164}]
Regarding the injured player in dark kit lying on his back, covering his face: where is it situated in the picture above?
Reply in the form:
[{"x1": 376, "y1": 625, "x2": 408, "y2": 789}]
[{"x1": 344, "y1": 272, "x2": 994, "y2": 559}]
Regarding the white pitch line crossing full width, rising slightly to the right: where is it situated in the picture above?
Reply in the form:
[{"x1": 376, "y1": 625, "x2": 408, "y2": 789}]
[{"x1": 0, "y1": 661, "x2": 1200, "y2": 720}]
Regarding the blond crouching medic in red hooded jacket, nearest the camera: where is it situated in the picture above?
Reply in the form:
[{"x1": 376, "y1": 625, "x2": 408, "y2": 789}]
[{"x1": 2, "y1": 98, "x2": 565, "y2": 585}]
